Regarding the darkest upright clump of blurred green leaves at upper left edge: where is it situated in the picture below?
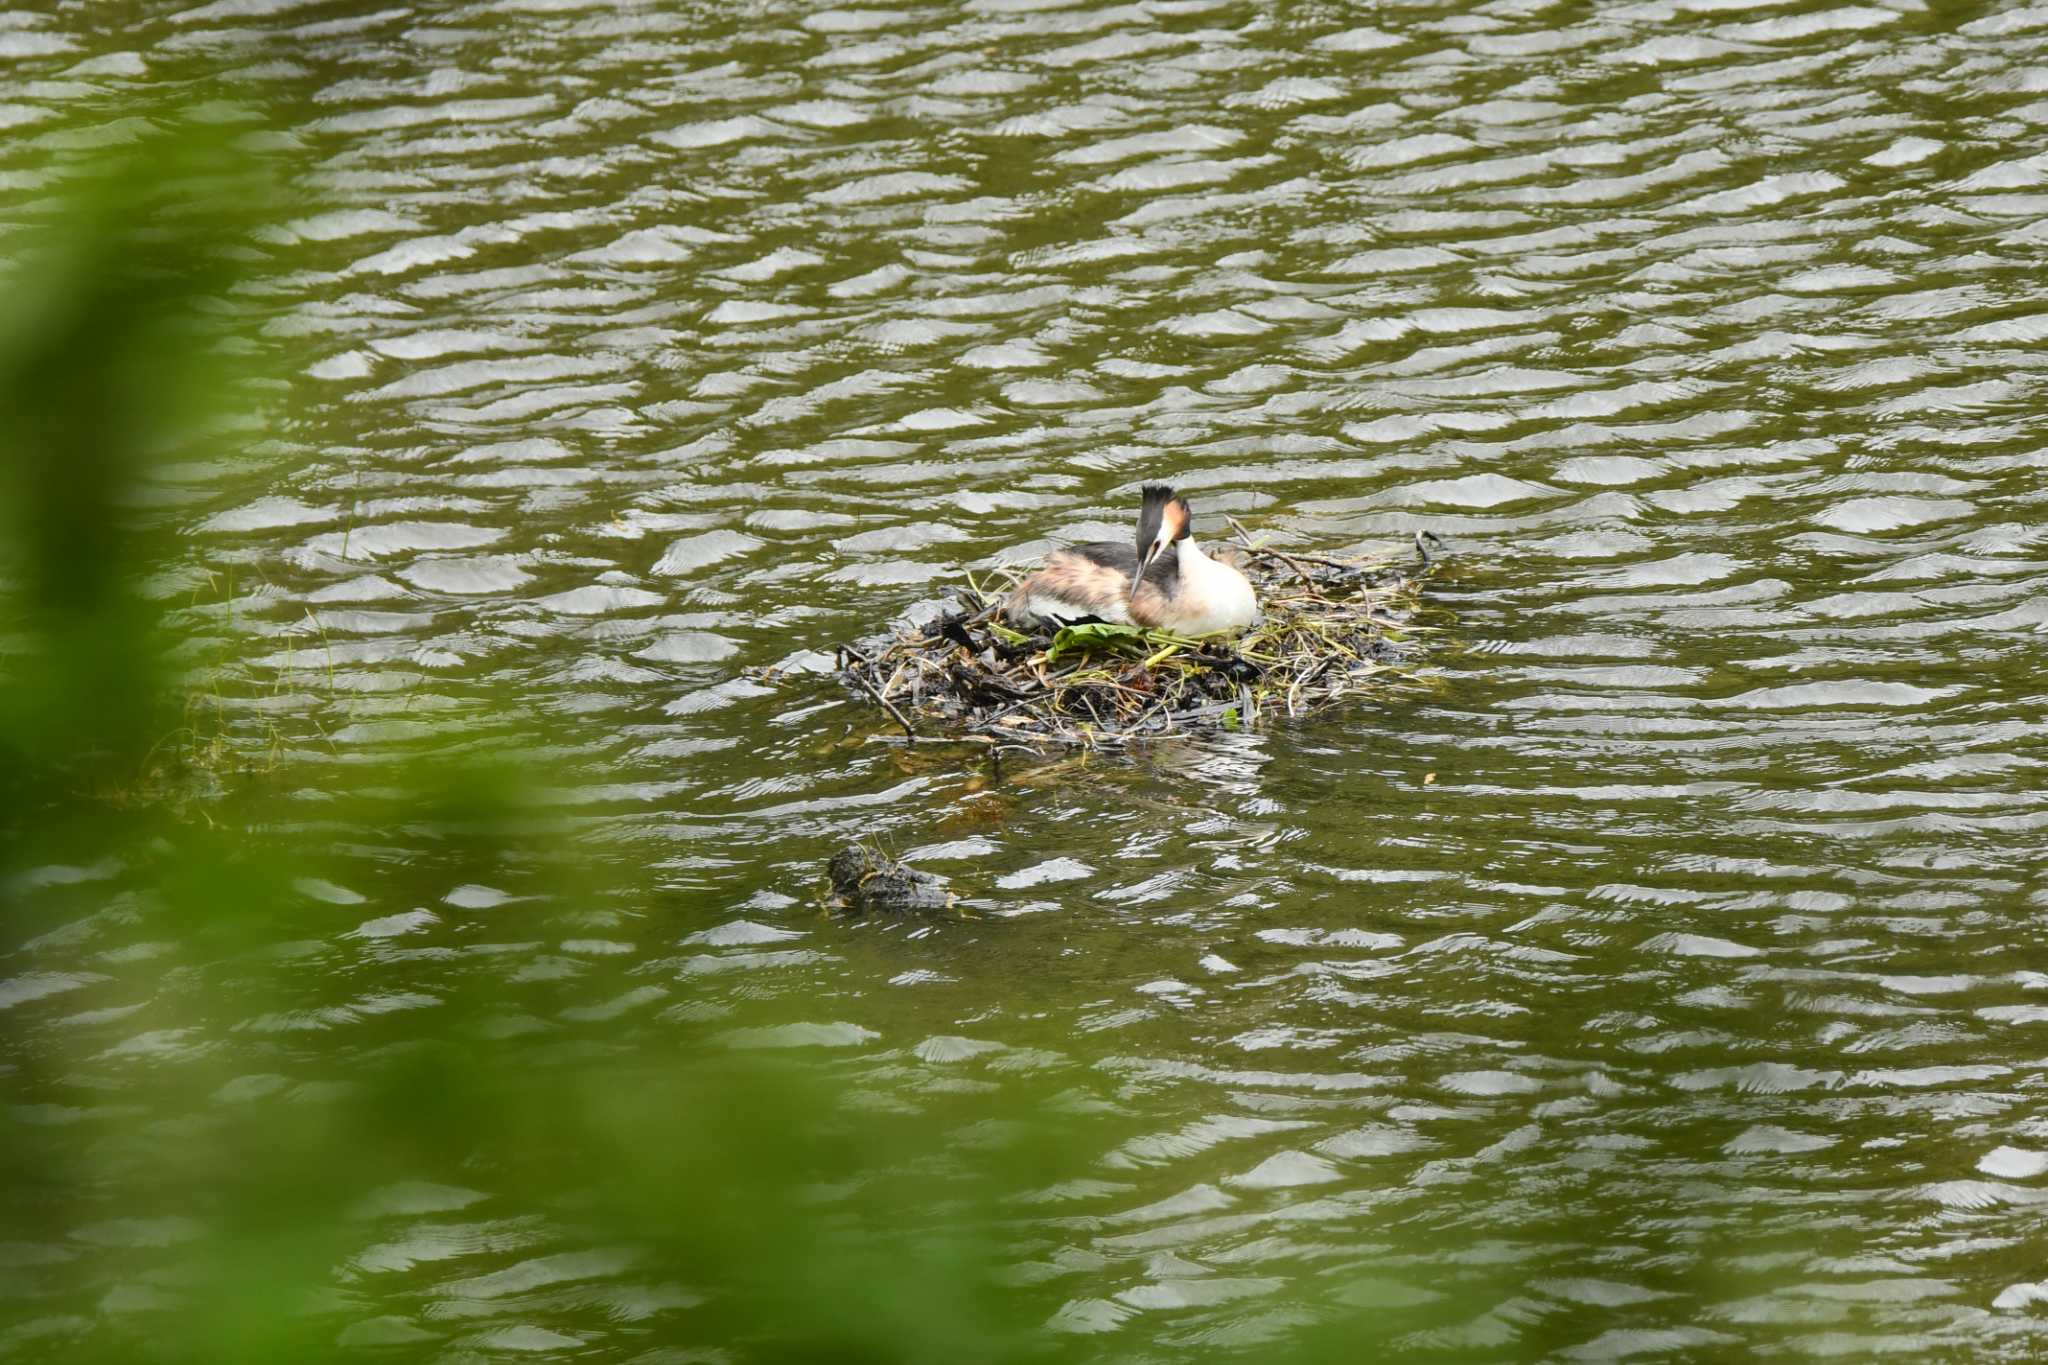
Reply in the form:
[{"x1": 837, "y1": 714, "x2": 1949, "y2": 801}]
[{"x1": 0, "y1": 111, "x2": 268, "y2": 812}]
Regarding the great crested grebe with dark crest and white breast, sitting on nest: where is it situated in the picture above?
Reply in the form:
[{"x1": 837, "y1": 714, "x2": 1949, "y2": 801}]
[{"x1": 1004, "y1": 483, "x2": 1260, "y2": 634}]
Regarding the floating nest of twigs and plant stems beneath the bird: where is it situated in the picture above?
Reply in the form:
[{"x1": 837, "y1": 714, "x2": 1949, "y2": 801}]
[{"x1": 838, "y1": 538, "x2": 1434, "y2": 751}]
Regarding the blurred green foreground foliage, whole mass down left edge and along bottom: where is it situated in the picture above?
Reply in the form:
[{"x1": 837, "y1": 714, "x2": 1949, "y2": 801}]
[{"x1": 0, "y1": 101, "x2": 1507, "y2": 1363}]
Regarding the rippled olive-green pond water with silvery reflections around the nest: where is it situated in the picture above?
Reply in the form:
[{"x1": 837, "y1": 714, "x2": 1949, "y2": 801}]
[{"x1": 0, "y1": 0, "x2": 2048, "y2": 1361}]
